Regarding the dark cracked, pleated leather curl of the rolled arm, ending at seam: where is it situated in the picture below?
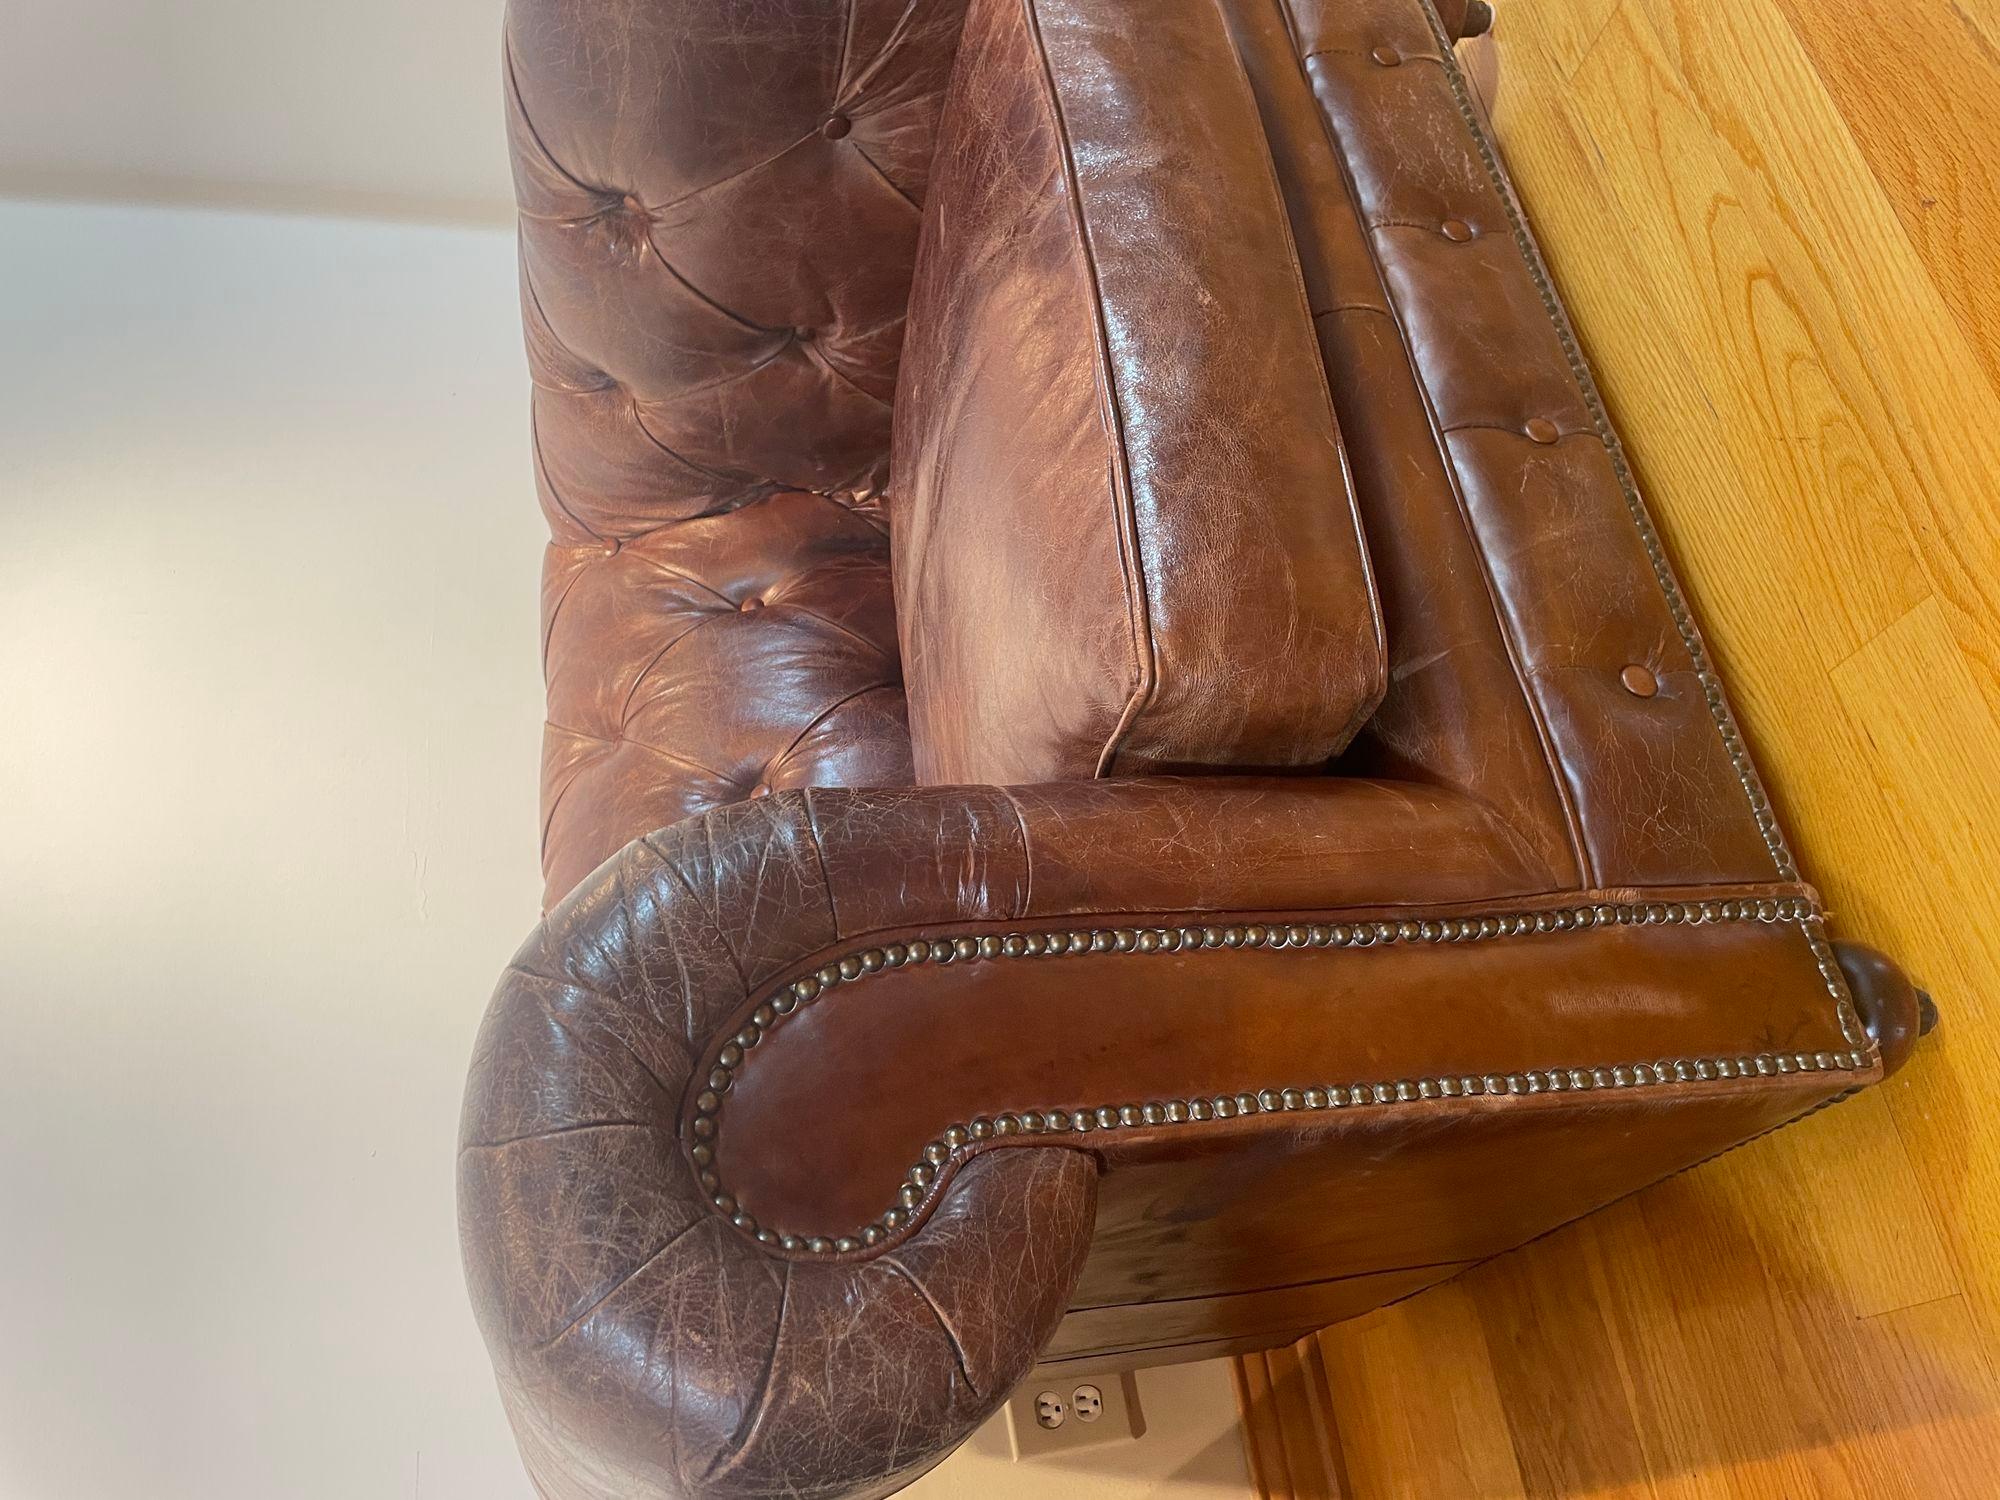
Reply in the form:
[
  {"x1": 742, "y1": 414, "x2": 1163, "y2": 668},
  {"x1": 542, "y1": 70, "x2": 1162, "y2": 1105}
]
[{"x1": 460, "y1": 794, "x2": 1094, "y2": 1500}]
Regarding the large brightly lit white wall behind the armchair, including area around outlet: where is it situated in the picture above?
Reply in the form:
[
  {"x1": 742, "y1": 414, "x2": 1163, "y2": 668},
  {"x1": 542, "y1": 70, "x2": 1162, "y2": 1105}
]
[{"x1": 0, "y1": 202, "x2": 1246, "y2": 1500}]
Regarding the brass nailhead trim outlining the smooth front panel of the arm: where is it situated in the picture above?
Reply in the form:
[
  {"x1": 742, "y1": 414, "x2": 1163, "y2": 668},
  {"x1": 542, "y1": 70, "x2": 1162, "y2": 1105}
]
[{"x1": 688, "y1": 896, "x2": 1872, "y2": 1256}]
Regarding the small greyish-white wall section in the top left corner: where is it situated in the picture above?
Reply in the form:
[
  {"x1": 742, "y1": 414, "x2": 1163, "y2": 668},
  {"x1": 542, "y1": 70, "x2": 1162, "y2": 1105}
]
[{"x1": 0, "y1": 0, "x2": 512, "y2": 224}]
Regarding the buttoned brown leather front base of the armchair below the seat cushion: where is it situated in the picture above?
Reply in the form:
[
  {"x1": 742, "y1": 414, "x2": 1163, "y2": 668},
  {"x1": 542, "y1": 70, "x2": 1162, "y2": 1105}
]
[{"x1": 1264, "y1": 0, "x2": 1782, "y2": 884}]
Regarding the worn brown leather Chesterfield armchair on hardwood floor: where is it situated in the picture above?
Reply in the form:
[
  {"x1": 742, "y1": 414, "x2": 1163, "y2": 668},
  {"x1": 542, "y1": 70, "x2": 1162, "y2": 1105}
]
[{"x1": 460, "y1": 0, "x2": 1926, "y2": 1500}]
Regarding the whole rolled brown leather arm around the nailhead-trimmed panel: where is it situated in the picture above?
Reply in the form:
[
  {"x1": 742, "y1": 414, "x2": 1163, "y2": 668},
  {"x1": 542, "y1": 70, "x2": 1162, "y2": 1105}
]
[{"x1": 460, "y1": 780, "x2": 1546, "y2": 1500}]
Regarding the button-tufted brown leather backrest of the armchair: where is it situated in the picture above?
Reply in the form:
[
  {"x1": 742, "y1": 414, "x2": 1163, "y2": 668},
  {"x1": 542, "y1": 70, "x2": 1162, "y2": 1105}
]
[{"x1": 506, "y1": 0, "x2": 964, "y2": 900}]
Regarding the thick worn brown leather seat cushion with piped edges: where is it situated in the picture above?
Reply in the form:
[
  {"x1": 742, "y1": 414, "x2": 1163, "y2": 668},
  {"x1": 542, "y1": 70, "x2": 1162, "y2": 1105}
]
[{"x1": 890, "y1": 0, "x2": 1386, "y2": 784}]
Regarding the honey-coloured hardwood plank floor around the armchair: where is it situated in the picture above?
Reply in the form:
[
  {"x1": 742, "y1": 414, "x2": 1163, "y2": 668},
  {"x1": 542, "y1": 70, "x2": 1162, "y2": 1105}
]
[{"x1": 1240, "y1": 0, "x2": 2000, "y2": 1500}]
